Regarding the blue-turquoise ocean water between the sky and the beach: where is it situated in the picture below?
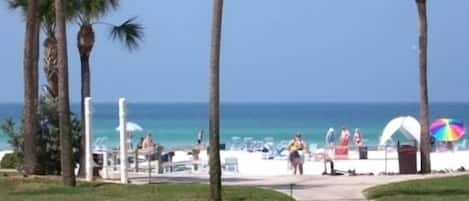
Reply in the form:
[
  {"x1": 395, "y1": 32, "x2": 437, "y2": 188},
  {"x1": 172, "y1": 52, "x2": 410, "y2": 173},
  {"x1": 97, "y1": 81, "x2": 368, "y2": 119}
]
[{"x1": 0, "y1": 103, "x2": 469, "y2": 149}]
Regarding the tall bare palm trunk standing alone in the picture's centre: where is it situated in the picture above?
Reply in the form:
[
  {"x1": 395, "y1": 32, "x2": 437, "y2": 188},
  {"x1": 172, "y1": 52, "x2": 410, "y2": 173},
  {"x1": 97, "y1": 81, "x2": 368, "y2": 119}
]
[{"x1": 209, "y1": 0, "x2": 223, "y2": 201}]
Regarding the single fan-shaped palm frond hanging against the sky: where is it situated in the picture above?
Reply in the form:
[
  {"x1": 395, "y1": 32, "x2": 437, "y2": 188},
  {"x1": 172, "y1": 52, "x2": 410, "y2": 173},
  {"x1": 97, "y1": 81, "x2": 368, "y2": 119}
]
[{"x1": 110, "y1": 17, "x2": 143, "y2": 51}]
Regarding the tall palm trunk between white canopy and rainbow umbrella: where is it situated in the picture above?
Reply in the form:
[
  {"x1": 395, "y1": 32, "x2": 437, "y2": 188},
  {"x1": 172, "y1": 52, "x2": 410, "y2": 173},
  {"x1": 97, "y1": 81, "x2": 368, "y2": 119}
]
[{"x1": 415, "y1": 0, "x2": 431, "y2": 174}]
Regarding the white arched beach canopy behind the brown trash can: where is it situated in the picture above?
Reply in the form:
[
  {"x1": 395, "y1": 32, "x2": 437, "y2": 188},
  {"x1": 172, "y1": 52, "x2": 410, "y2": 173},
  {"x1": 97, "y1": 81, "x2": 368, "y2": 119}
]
[{"x1": 379, "y1": 116, "x2": 420, "y2": 146}]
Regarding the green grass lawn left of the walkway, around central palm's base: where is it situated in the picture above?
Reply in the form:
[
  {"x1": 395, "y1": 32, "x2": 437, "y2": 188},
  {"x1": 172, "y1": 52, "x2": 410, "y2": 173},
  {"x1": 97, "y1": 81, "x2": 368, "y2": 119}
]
[{"x1": 0, "y1": 177, "x2": 293, "y2": 201}]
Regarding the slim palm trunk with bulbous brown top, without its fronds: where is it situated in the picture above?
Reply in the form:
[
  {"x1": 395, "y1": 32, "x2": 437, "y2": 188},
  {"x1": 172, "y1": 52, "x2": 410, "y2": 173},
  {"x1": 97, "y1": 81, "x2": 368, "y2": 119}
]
[{"x1": 77, "y1": 25, "x2": 94, "y2": 176}]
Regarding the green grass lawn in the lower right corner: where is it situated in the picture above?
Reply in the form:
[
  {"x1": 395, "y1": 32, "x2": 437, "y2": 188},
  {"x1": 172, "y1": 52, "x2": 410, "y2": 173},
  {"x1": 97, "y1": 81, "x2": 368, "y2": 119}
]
[{"x1": 364, "y1": 175, "x2": 469, "y2": 201}]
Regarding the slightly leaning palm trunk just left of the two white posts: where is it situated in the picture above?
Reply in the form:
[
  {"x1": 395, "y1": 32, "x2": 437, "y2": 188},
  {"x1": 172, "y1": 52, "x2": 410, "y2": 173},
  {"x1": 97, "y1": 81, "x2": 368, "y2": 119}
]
[{"x1": 55, "y1": 0, "x2": 76, "y2": 186}]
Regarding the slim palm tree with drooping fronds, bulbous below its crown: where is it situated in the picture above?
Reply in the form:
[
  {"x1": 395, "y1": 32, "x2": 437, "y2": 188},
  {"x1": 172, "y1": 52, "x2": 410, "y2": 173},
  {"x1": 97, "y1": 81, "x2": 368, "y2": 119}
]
[{"x1": 76, "y1": 0, "x2": 143, "y2": 175}]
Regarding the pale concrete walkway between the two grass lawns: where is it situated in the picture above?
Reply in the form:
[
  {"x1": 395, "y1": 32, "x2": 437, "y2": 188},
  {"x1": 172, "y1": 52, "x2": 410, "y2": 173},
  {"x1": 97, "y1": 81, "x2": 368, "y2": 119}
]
[{"x1": 131, "y1": 174, "x2": 431, "y2": 201}]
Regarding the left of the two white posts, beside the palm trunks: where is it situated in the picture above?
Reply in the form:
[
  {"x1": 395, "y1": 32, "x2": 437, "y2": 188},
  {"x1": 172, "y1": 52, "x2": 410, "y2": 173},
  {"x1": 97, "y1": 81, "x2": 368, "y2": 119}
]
[{"x1": 85, "y1": 97, "x2": 94, "y2": 181}]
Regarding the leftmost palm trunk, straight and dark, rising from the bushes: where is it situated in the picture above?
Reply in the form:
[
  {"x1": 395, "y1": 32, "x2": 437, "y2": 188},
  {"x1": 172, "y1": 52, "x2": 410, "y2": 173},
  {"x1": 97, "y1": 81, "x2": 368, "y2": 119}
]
[{"x1": 23, "y1": 0, "x2": 39, "y2": 174}]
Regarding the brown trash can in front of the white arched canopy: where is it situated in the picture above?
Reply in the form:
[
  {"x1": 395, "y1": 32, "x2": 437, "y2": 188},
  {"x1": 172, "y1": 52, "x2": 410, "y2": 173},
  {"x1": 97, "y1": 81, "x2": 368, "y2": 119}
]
[{"x1": 398, "y1": 145, "x2": 417, "y2": 174}]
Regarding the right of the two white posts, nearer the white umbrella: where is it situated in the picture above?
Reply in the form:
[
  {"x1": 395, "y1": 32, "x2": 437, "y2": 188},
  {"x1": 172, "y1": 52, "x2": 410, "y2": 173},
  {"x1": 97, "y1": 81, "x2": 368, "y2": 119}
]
[{"x1": 119, "y1": 98, "x2": 128, "y2": 184}]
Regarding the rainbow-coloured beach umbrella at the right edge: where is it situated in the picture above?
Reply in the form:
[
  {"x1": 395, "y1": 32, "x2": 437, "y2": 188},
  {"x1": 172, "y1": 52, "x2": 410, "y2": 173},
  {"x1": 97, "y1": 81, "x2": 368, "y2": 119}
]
[{"x1": 430, "y1": 118, "x2": 466, "y2": 142}]
